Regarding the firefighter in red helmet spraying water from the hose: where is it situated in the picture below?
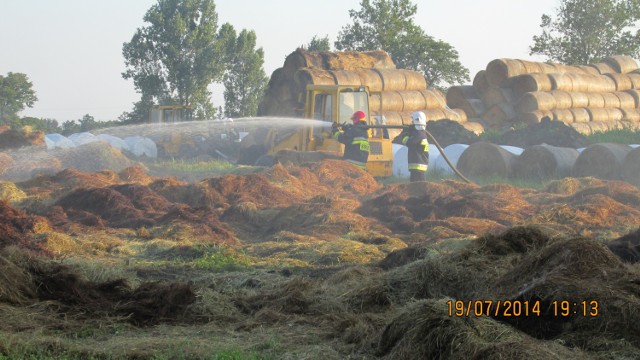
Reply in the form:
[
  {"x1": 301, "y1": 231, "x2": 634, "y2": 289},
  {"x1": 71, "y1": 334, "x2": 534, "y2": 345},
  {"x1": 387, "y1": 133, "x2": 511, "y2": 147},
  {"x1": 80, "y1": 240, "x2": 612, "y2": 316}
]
[{"x1": 332, "y1": 111, "x2": 369, "y2": 170}]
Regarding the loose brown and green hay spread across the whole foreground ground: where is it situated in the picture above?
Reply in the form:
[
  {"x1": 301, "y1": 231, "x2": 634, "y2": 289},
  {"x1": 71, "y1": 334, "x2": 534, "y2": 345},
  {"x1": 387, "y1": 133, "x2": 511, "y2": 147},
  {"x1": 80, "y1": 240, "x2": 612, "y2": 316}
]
[{"x1": 0, "y1": 160, "x2": 640, "y2": 359}]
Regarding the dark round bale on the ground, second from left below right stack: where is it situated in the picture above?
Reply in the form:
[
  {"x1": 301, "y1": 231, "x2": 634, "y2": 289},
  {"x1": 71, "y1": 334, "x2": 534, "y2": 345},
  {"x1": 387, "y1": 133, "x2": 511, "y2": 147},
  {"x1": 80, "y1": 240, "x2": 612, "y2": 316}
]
[{"x1": 513, "y1": 144, "x2": 580, "y2": 180}]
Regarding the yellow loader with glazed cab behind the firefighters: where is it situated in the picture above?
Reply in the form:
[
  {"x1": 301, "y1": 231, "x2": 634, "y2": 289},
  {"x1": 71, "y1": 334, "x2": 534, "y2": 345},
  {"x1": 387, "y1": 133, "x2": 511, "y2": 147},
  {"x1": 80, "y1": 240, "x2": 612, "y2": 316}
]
[{"x1": 239, "y1": 85, "x2": 393, "y2": 177}]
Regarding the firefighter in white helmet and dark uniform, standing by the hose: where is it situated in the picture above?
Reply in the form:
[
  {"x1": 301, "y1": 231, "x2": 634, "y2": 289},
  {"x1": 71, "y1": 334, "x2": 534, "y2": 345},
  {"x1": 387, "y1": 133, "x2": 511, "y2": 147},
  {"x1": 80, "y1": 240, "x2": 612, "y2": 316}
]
[{"x1": 393, "y1": 111, "x2": 429, "y2": 182}]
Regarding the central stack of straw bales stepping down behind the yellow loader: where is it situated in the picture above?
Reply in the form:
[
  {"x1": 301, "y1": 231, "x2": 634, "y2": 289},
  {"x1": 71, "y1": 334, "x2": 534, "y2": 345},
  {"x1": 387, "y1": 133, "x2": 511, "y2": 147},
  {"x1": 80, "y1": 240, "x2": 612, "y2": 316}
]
[{"x1": 258, "y1": 49, "x2": 483, "y2": 136}]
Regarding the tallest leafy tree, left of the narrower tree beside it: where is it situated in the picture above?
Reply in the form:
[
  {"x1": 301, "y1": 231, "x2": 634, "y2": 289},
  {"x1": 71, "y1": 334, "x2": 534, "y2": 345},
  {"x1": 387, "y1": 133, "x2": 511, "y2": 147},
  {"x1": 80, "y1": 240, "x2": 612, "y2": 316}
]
[{"x1": 122, "y1": 0, "x2": 230, "y2": 119}]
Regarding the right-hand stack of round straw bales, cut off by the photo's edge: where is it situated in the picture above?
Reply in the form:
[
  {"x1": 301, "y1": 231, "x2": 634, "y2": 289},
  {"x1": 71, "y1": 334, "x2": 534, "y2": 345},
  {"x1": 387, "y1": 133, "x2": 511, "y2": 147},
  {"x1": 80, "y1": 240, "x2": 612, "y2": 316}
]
[{"x1": 447, "y1": 56, "x2": 640, "y2": 134}]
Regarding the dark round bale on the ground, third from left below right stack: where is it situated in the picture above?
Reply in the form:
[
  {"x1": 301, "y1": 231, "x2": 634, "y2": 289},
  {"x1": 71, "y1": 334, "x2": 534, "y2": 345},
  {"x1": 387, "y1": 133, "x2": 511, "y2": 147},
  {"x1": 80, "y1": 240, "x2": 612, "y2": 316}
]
[{"x1": 572, "y1": 143, "x2": 631, "y2": 180}]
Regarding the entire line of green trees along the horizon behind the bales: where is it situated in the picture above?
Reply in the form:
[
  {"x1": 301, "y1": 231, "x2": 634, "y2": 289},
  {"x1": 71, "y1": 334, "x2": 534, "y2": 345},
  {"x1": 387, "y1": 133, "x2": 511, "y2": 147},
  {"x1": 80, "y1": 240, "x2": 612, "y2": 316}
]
[{"x1": 0, "y1": 0, "x2": 640, "y2": 134}]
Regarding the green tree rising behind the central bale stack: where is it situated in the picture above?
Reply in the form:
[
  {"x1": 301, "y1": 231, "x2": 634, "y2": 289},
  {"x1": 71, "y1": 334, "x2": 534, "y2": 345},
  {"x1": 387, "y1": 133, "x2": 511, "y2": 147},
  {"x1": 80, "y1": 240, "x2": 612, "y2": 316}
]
[{"x1": 335, "y1": 0, "x2": 470, "y2": 87}]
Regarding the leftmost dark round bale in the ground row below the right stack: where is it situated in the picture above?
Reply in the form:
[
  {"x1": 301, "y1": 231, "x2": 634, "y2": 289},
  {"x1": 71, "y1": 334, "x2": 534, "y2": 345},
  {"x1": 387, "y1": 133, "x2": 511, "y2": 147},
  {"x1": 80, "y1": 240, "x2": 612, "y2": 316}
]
[{"x1": 456, "y1": 142, "x2": 516, "y2": 178}]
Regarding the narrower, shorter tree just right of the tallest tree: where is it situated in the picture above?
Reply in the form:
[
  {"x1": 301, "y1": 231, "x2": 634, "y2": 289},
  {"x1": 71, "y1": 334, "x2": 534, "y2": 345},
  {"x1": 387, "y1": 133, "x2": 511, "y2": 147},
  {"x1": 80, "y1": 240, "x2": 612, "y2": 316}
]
[{"x1": 223, "y1": 29, "x2": 269, "y2": 117}]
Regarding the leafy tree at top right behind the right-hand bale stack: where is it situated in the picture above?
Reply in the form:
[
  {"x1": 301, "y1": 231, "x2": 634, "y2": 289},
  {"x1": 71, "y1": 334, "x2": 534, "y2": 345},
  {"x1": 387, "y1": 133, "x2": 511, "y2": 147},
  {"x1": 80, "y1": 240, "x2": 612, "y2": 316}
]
[{"x1": 530, "y1": 0, "x2": 640, "y2": 65}]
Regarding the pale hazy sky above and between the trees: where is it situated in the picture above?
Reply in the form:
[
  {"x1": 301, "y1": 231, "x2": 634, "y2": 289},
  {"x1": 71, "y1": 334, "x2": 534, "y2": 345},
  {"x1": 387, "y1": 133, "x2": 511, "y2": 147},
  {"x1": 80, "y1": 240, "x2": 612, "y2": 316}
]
[{"x1": 0, "y1": 0, "x2": 560, "y2": 122}]
